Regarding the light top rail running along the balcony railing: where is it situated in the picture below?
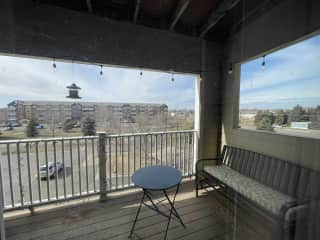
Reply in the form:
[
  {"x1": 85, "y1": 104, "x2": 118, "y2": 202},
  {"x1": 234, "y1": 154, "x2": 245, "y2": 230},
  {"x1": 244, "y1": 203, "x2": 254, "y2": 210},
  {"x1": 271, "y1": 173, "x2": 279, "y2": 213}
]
[{"x1": 0, "y1": 130, "x2": 196, "y2": 145}]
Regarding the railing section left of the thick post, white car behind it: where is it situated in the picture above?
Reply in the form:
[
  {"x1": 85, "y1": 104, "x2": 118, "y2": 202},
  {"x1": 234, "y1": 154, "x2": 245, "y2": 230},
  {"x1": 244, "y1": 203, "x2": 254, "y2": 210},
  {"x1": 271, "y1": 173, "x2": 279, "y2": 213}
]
[{"x1": 0, "y1": 136, "x2": 99, "y2": 210}]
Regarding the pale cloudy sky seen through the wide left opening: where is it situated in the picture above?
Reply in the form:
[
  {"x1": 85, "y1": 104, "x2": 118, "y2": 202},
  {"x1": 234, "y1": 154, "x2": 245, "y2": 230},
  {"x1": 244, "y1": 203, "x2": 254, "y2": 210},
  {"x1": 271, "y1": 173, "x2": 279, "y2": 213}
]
[{"x1": 0, "y1": 56, "x2": 196, "y2": 110}]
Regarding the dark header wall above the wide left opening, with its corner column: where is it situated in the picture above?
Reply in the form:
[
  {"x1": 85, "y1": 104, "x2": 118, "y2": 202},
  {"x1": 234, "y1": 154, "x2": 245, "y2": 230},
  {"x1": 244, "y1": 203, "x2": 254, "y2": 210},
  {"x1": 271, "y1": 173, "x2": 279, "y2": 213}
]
[{"x1": 0, "y1": 0, "x2": 221, "y2": 157}]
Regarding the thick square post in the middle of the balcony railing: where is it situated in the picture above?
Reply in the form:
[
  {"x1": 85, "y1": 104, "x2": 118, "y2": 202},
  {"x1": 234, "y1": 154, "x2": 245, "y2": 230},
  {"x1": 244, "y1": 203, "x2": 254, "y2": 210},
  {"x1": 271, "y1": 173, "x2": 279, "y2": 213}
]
[{"x1": 98, "y1": 132, "x2": 107, "y2": 202}]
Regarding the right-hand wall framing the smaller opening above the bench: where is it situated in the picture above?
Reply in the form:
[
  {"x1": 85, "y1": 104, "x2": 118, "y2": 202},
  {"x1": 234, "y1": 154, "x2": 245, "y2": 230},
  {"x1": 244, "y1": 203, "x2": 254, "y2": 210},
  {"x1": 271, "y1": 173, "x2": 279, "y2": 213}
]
[{"x1": 222, "y1": 0, "x2": 320, "y2": 169}]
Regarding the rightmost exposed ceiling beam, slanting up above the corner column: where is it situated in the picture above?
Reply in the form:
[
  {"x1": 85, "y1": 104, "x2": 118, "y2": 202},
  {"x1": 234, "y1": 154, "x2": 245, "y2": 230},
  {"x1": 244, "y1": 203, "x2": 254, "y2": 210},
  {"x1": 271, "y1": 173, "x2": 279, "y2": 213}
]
[{"x1": 200, "y1": 0, "x2": 240, "y2": 38}]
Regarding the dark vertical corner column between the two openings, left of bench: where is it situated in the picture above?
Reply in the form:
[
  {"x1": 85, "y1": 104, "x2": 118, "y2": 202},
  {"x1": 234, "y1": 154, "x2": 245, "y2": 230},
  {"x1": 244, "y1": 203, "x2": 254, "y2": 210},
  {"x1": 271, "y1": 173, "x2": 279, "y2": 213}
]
[{"x1": 199, "y1": 41, "x2": 223, "y2": 158}]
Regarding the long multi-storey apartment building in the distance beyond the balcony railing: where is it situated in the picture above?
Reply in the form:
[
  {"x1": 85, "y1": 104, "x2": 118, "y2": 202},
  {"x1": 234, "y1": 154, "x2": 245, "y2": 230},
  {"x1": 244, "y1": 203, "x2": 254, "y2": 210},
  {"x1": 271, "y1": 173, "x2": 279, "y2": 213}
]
[{"x1": 8, "y1": 100, "x2": 168, "y2": 125}]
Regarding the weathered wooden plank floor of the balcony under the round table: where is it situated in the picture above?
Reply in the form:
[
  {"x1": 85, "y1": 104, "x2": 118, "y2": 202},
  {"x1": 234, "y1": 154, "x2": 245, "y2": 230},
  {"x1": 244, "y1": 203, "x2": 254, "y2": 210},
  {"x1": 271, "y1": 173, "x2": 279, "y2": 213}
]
[{"x1": 6, "y1": 179, "x2": 272, "y2": 240}]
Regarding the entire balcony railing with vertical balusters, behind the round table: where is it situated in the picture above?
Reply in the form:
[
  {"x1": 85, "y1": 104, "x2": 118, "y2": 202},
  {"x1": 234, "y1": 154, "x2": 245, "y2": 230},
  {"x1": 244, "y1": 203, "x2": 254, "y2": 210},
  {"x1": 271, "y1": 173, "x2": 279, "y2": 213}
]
[{"x1": 0, "y1": 131, "x2": 196, "y2": 210}]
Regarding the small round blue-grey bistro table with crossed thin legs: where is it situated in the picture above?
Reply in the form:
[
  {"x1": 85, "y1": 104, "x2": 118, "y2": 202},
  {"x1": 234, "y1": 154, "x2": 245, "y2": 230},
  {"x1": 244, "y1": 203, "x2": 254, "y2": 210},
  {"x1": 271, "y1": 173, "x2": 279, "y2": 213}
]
[{"x1": 129, "y1": 166, "x2": 185, "y2": 239}]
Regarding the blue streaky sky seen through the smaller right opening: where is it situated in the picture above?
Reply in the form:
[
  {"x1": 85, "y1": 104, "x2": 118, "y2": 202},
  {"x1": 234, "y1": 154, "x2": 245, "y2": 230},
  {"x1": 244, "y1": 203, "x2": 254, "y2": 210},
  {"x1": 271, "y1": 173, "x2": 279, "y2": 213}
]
[{"x1": 240, "y1": 35, "x2": 320, "y2": 109}]
